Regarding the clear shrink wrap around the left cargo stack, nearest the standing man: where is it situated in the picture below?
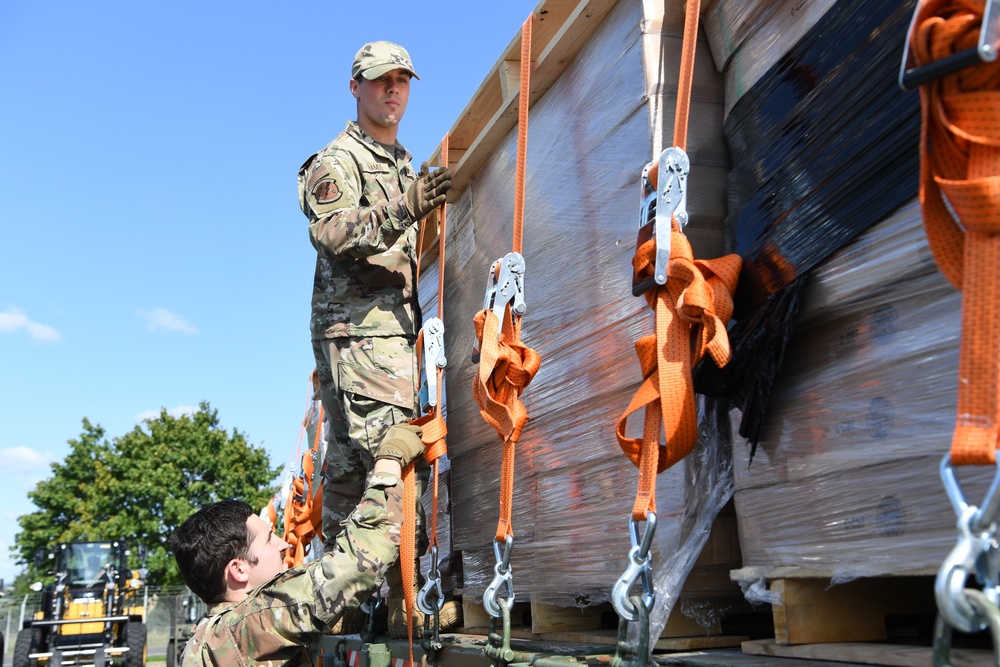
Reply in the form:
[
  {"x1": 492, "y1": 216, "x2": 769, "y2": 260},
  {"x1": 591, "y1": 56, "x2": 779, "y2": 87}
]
[{"x1": 425, "y1": 0, "x2": 739, "y2": 636}]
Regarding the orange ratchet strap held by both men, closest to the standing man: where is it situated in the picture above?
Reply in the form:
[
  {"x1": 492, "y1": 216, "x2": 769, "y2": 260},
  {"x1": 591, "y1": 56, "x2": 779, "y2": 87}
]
[{"x1": 399, "y1": 134, "x2": 449, "y2": 664}]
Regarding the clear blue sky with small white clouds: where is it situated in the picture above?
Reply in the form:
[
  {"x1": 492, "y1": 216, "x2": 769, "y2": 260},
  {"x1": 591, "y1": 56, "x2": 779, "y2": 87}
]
[{"x1": 0, "y1": 0, "x2": 537, "y2": 582}]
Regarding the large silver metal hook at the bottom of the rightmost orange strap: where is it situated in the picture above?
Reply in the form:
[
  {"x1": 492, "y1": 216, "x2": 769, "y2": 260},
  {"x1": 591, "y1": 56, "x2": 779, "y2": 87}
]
[{"x1": 934, "y1": 454, "x2": 1000, "y2": 633}]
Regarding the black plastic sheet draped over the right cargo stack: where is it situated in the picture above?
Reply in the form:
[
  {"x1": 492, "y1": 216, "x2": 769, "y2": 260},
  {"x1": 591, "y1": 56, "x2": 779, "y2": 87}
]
[{"x1": 696, "y1": 0, "x2": 920, "y2": 447}]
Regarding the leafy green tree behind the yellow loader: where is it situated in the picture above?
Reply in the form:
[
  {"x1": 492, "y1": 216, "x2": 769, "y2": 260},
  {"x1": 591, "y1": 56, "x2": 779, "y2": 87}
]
[{"x1": 13, "y1": 402, "x2": 278, "y2": 585}]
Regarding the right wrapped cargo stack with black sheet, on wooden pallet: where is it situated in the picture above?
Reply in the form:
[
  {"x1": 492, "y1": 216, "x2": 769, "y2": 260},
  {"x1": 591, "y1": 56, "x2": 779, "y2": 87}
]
[{"x1": 705, "y1": 0, "x2": 993, "y2": 665}]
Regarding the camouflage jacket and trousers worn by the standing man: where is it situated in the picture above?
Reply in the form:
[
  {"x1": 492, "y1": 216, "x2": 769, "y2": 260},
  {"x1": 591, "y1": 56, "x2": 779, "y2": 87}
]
[{"x1": 298, "y1": 121, "x2": 427, "y2": 548}]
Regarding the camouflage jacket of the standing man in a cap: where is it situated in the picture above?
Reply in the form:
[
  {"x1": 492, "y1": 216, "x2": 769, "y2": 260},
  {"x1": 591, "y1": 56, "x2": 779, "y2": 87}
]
[{"x1": 298, "y1": 121, "x2": 420, "y2": 339}]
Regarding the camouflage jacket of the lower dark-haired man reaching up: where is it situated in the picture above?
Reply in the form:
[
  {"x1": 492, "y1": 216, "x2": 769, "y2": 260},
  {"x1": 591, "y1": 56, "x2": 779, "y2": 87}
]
[{"x1": 183, "y1": 473, "x2": 403, "y2": 667}]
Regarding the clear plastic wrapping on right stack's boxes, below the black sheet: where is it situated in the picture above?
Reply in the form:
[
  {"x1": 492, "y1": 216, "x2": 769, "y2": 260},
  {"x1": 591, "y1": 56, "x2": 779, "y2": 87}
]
[{"x1": 734, "y1": 203, "x2": 994, "y2": 580}]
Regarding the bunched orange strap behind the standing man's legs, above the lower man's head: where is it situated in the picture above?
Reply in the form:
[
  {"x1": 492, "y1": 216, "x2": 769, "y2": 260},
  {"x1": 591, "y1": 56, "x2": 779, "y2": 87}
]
[{"x1": 283, "y1": 396, "x2": 323, "y2": 567}]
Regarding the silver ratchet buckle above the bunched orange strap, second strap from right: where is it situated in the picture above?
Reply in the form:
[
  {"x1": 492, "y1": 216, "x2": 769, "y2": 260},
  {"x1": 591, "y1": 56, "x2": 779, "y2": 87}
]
[{"x1": 632, "y1": 147, "x2": 692, "y2": 296}]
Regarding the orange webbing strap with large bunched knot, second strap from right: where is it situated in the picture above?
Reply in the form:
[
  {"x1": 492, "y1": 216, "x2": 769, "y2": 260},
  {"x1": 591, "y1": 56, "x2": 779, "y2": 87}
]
[{"x1": 616, "y1": 0, "x2": 742, "y2": 521}]
